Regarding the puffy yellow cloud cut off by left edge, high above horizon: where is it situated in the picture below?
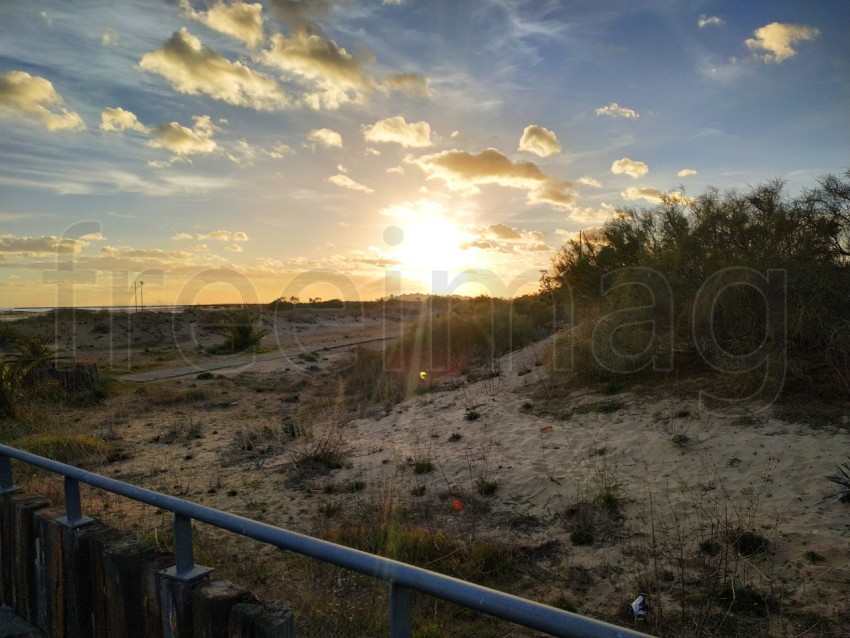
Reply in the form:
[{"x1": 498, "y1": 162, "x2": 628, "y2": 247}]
[{"x1": 0, "y1": 71, "x2": 86, "y2": 131}]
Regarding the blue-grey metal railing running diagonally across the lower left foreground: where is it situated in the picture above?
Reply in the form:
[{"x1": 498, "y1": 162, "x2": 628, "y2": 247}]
[{"x1": 0, "y1": 445, "x2": 646, "y2": 638}]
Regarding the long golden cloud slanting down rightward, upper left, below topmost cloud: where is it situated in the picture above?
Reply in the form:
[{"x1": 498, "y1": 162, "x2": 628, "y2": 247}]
[{"x1": 139, "y1": 27, "x2": 291, "y2": 111}]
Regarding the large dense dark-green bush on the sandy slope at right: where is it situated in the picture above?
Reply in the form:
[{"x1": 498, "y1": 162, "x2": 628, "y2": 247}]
[{"x1": 543, "y1": 171, "x2": 850, "y2": 399}]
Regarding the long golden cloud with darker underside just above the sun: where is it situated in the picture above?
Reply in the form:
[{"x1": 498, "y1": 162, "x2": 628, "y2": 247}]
[{"x1": 407, "y1": 148, "x2": 575, "y2": 206}]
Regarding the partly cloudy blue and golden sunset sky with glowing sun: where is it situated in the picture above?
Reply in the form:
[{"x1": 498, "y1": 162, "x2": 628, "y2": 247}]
[{"x1": 0, "y1": 0, "x2": 850, "y2": 307}]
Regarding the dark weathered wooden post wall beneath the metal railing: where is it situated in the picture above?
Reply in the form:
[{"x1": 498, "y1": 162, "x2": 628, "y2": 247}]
[{"x1": 0, "y1": 492, "x2": 295, "y2": 638}]
